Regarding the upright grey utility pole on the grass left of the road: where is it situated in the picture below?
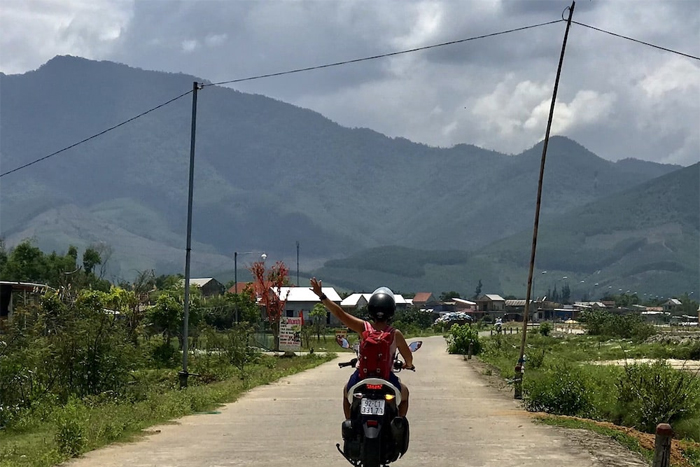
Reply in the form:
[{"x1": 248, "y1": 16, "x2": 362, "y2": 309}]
[{"x1": 179, "y1": 81, "x2": 201, "y2": 389}]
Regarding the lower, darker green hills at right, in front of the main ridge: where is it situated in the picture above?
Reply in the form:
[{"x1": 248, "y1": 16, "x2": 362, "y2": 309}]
[{"x1": 314, "y1": 164, "x2": 700, "y2": 299}]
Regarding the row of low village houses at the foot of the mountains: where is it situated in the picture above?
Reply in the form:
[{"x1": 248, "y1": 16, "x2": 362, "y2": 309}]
[{"x1": 0, "y1": 277, "x2": 700, "y2": 326}]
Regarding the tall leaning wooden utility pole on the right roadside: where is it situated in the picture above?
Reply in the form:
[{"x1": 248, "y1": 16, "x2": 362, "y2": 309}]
[{"x1": 514, "y1": 1, "x2": 576, "y2": 399}]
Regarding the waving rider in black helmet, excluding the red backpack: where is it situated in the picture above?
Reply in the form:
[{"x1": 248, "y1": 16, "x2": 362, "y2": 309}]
[{"x1": 311, "y1": 277, "x2": 414, "y2": 419}]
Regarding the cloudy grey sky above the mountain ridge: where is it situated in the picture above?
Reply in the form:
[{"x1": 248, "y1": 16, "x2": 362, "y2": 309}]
[{"x1": 0, "y1": 0, "x2": 700, "y2": 166}]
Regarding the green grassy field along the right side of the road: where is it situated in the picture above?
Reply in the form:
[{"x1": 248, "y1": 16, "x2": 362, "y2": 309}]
[{"x1": 479, "y1": 335, "x2": 700, "y2": 438}]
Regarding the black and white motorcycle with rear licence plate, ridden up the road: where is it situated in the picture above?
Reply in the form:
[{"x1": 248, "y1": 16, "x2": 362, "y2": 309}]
[{"x1": 336, "y1": 339, "x2": 423, "y2": 467}]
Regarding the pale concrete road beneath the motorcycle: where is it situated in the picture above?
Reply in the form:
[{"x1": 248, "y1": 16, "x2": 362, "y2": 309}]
[{"x1": 69, "y1": 337, "x2": 647, "y2": 467}]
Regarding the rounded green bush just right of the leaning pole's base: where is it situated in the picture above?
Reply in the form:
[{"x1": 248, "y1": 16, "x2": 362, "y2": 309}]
[{"x1": 523, "y1": 365, "x2": 593, "y2": 417}]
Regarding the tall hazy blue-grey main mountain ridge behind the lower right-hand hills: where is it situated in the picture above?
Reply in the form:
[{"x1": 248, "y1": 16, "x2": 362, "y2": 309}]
[{"x1": 0, "y1": 56, "x2": 678, "y2": 284}]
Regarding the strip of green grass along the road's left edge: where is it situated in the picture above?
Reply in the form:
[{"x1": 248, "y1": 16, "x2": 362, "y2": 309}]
[{"x1": 0, "y1": 354, "x2": 335, "y2": 467}]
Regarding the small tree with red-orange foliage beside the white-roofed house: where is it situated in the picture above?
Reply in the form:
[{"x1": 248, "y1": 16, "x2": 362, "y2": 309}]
[{"x1": 249, "y1": 261, "x2": 289, "y2": 350}]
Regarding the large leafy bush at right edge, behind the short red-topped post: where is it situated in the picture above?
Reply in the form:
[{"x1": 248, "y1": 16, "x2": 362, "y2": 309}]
[{"x1": 616, "y1": 361, "x2": 700, "y2": 433}]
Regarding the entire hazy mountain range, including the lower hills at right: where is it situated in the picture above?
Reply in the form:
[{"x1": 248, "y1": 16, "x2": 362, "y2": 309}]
[{"x1": 0, "y1": 56, "x2": 700, "y2": 293}]
